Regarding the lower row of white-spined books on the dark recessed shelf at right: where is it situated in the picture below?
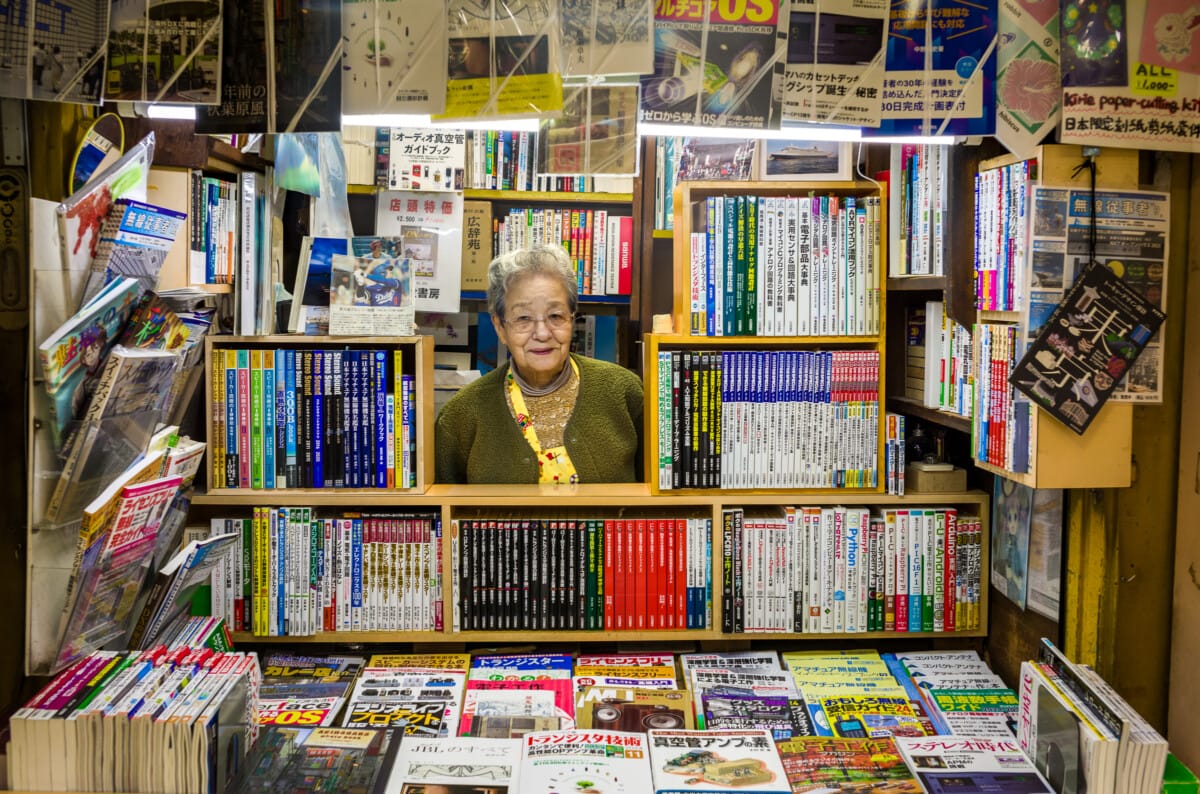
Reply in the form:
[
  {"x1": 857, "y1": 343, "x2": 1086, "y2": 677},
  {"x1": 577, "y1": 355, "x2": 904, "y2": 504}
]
[{"x1": 905, "y1": 301, "x2": 976, "y2": 416}]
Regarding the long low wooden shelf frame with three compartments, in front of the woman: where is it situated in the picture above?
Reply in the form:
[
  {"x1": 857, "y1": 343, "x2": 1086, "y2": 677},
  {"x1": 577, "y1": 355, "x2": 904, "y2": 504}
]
[{"x1": 218, "y1": 483, "x2": 990, "y2": 645}]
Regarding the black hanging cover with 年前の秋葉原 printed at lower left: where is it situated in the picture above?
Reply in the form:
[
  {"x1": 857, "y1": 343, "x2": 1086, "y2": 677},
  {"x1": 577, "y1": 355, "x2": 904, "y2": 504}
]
[{"x1": 196, "y1": 0, "x2": 342, "y2": 134}]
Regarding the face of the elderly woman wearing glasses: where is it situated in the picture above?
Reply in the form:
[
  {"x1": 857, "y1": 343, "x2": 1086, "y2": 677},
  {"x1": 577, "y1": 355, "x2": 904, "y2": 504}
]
[{"x1": 492, "y1": 273, "x2": 574, "y2": 386}]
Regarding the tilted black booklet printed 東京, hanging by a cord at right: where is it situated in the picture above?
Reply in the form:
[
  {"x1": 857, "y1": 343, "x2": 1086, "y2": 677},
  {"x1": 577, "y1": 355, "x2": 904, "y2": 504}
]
[{"x1": 1008, "y1": 263, "x2": 1166, "y2": 435}]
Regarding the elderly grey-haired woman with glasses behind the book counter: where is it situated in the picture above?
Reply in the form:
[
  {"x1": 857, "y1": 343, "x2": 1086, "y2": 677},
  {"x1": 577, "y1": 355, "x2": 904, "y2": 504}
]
[{"x1": 436, "y1": 246, "x2": 642, "y2": 483}]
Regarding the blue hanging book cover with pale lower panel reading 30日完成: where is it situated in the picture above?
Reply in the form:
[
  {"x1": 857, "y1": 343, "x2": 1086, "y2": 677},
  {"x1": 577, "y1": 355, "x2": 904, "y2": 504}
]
[{"x1": 864, "y1": 0, "x2": 998, "y2": 136}]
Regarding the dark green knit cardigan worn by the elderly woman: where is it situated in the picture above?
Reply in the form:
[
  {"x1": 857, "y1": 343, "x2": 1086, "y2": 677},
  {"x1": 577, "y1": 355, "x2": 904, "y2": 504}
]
[{"x1": 434, "y1": 354, "x2": 642, "y2": 483}]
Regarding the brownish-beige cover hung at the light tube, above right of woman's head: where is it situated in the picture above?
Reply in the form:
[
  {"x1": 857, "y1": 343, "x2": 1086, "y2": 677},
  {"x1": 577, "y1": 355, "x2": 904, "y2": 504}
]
[{"x1": 538, "y1": 83, "x2": 641, "y2": 175}]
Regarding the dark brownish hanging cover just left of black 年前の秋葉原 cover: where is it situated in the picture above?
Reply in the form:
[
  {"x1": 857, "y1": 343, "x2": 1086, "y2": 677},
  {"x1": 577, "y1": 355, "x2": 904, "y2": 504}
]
[{"x1": 104, "y1": 0, "x2": 223, "y2": 104}]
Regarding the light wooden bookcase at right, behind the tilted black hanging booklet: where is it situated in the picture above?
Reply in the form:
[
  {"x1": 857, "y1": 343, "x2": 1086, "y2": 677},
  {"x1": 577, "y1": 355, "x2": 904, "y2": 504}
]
[{"x1": 972, "y1": 144, "x2": 1138, "y2": 488}]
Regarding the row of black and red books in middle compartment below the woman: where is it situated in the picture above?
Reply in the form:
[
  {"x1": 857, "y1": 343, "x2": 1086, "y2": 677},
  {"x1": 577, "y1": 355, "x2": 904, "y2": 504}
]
[{"x1": 454, "y1": 518, "x2": 712, "y2": 631}]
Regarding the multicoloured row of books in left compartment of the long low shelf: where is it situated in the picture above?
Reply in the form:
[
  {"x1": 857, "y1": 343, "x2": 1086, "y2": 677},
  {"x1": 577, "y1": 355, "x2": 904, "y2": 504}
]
[{"x1": 211, "y1": 507, "x2": 442, "y2": 637}]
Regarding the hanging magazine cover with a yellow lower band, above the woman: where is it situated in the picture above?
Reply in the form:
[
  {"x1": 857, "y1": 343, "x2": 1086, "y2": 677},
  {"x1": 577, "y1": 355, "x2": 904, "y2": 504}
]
[{"x1": 434, "y1": 0, "x2": 563, "y2": 120}]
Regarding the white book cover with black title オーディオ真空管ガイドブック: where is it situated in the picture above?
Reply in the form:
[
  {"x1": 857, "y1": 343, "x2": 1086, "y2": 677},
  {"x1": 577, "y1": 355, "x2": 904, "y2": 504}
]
[{"x1": 388, "y1": 127, "x2": 467, "y2": 191}]
